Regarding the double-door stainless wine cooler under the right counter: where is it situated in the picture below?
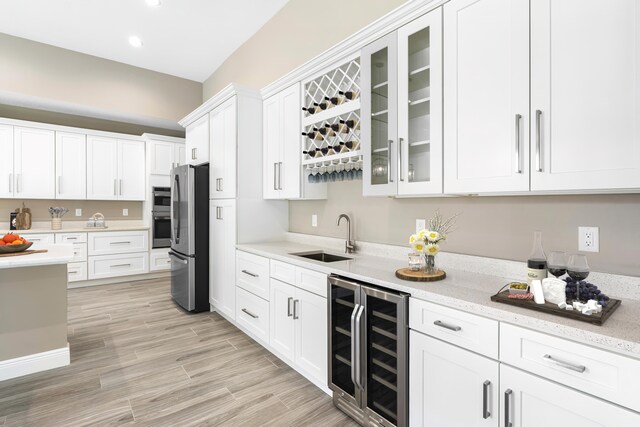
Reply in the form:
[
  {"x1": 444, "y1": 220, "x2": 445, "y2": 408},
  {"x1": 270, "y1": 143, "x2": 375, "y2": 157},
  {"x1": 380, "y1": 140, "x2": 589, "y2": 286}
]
[{"x1": 328, "y1": 275, "x2": 409, "y2": 426}]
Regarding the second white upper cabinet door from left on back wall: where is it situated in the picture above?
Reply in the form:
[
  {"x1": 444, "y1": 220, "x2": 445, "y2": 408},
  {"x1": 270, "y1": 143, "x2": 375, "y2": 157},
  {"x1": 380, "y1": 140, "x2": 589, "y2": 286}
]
[{"x1": 13, "y1": 127, "x2": 56, "y2": 199}]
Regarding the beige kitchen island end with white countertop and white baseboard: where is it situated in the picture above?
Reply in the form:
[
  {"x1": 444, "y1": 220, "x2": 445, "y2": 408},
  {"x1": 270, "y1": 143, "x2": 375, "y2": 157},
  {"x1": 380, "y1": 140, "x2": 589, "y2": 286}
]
[{"x1": 0, "y1": 245, "x2": 73, "y2": 381}]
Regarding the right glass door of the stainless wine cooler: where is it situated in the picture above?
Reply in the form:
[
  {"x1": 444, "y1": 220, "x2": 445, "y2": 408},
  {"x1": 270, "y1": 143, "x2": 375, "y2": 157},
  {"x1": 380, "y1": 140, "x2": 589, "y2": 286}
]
[{"x1": 360, "y1": 286, "x2": 408, "y2": 426}]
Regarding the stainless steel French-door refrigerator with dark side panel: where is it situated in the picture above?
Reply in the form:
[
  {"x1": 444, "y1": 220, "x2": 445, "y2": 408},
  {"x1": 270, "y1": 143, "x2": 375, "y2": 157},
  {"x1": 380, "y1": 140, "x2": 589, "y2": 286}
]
[{"x1": 169, "y1": 165, "x2": 209, "y2": 311}]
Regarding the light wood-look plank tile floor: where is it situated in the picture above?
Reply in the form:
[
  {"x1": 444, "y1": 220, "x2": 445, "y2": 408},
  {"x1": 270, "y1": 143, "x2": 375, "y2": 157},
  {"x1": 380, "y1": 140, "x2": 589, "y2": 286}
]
[{"x1": 0, "y1": 280, "x2": 356, "y2": 427}]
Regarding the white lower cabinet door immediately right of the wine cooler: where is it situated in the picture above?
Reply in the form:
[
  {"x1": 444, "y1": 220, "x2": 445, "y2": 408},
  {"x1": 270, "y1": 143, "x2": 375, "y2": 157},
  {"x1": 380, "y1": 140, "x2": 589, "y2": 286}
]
[{"x1": 409, "y1": 331, "x2": 499, "y2": 427}]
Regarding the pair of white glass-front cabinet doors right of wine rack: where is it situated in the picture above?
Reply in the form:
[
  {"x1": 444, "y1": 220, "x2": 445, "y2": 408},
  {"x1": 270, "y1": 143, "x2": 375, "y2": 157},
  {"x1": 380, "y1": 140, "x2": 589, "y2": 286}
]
[{"x1": 361, "y1": 8, "x2": 442, "y2": 196}]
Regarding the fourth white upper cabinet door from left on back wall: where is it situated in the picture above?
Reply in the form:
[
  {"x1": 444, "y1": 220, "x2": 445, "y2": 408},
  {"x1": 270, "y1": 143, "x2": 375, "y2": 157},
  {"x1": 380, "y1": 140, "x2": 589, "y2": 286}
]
[{"x1": 87, "y1": 135, "x2": 119, "y2": 200}]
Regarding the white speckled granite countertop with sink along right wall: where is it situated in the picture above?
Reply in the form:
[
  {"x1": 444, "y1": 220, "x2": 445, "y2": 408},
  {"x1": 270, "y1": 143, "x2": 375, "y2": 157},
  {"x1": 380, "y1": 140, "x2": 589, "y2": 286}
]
[{"x1": 237, "y1": 241, "x2": 640, "y2": 359}]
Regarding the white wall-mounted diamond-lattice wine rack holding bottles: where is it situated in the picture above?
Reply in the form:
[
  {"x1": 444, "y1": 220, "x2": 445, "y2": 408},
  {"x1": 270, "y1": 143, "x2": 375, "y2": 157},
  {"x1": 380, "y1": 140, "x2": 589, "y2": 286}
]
[{"x1": 302, "y1": 58, "x2": 362, "y2": 182}]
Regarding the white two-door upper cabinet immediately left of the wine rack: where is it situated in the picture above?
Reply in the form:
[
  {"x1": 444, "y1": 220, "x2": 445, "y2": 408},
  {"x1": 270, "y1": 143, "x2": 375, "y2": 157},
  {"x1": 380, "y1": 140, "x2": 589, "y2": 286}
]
[{"x1": 262, "y1": 83, "x2": 301, "y2": 199}]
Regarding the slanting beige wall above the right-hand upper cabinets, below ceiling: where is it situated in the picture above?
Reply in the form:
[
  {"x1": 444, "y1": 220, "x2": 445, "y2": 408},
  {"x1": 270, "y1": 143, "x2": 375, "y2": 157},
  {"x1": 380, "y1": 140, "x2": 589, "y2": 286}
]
[{"x1": 203, "y1": 0, "x2": 404, "y2": 100}]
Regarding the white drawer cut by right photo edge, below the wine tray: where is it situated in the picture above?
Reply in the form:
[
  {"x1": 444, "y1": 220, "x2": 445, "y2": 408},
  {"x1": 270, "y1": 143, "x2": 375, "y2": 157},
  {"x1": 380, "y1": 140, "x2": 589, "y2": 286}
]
[{"x1": 500, "y1": 323, "x2": 640, "y2": 411}]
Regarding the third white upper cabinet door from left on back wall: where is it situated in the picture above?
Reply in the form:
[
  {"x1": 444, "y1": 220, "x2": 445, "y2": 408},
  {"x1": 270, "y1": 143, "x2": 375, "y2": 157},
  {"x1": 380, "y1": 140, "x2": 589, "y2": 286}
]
[{"x1": 56, "y1": 132, "x2": 87, "y2": 200}]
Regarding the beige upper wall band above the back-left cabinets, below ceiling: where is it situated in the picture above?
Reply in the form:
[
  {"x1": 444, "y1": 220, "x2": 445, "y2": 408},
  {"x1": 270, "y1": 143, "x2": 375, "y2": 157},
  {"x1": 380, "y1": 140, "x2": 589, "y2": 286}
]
[{"x1": 0, "y1": 34, "x2": 202, "y2": 131}]
